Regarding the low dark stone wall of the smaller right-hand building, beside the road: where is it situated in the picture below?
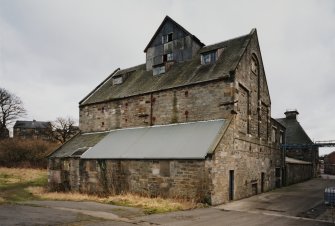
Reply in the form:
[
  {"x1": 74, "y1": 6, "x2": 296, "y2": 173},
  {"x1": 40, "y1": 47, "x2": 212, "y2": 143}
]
[{"x1": 285, "y1": 163, "x2": 313, "y2": 185}]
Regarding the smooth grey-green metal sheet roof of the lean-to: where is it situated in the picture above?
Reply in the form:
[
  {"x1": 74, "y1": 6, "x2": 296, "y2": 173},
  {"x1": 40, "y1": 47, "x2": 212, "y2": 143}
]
[{"x1": 81, "y1": 119, "x2": 227, "y2": 159}]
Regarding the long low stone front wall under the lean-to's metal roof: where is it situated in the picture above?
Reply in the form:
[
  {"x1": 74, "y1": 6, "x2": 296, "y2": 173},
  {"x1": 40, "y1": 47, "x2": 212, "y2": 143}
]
[{"x1": 49, "y1": 158, "x2": 210, "y2": 202}]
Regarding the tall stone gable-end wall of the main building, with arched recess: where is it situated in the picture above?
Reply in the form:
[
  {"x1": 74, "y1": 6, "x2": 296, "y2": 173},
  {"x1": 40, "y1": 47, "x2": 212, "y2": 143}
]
[{"x1": 202, "y1": 30, "x2": 283, "y2": 204}]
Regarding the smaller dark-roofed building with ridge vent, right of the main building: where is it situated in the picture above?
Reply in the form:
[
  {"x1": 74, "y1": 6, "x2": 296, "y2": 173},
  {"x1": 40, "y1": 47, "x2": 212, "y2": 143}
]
[{"x1": 276, "y1": 110, "x2": 320, "y2": 185}]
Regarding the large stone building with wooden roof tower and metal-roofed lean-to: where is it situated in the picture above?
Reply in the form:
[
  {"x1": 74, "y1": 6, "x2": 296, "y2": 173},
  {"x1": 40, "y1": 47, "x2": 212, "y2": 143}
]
[{"x1": 49, "y1": 16, "x2": 300, "y2": 205}]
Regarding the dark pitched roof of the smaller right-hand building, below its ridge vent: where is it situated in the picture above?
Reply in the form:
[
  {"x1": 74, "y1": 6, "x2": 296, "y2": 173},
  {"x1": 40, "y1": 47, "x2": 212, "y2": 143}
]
[{"x1": 276, "y1": 118, "x2": 313, "y2": 144}]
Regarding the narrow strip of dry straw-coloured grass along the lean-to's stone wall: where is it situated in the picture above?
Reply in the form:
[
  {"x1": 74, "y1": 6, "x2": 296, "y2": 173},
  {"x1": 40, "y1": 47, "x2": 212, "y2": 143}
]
[{"x1": 27, "y1": 187, "x2": 199, "y2": 214}]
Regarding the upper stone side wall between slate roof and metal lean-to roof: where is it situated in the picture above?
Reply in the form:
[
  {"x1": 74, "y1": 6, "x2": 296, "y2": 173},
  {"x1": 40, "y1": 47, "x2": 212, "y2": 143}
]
[{"x1": 79, "y1": 81, "x2": 234, "y2": 132}]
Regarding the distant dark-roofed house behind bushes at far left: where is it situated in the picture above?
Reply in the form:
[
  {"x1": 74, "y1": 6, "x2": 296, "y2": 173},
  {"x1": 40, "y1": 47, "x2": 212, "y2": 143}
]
[{"x1": 13, "y1": 120, "x2": 52, "y2": 140}]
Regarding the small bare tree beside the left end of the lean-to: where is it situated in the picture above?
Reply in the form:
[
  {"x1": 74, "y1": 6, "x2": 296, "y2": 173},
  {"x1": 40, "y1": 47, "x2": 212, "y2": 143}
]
[{"x1": 51, "y1": 117, "x2": 79, "y2": 144}]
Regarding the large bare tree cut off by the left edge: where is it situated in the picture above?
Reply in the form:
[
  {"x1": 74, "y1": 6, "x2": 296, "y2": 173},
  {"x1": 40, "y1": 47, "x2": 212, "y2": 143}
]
[{"x1": 0, "y1": 87, "x2": 26, "y2": 138}]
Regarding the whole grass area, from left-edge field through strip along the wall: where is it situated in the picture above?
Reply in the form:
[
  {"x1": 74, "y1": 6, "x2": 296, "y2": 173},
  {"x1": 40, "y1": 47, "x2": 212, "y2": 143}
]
[{"x1": 0, "y1": 167, "x2": 202, "y2": 214}]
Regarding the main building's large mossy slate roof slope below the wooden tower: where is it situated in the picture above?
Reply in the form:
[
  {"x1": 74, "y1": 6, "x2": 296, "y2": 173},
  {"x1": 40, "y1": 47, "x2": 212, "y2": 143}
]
[{"x1": 79, "y1": 29, "x2": 255, "y2": 106}]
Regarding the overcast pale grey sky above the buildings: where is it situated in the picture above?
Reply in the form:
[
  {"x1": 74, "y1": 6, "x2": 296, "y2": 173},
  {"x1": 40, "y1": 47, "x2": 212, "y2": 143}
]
[{"x1": 0, "y1": 0, "x2": 335, "y2": 154}]
